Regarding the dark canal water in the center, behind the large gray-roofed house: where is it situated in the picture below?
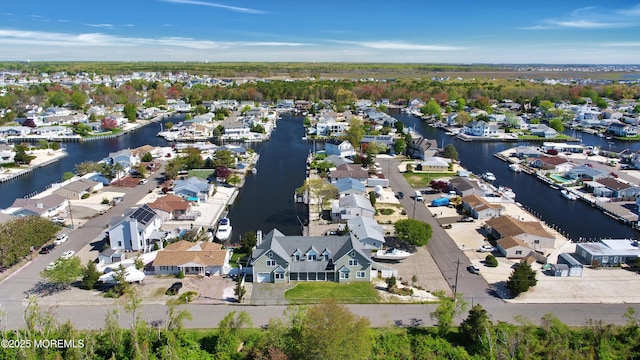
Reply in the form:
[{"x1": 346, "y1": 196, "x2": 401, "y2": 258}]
[{"x1": 229, "y1": 115, "x2": 311, "y2": 242}]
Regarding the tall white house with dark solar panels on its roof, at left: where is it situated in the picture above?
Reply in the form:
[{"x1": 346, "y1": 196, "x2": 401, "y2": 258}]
[{"x1": 107, "y1": 204, "x2": 162, "y2": 252}]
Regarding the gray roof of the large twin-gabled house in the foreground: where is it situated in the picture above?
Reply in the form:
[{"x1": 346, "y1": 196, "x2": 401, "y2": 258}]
[{"x1": 251, "y1": 229, "x2": 370, "y2": 271}]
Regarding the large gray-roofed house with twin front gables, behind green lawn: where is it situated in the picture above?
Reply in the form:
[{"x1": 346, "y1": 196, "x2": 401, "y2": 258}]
[{"x1": 250, "y1": 229, "x2": 372, "y2": 283}]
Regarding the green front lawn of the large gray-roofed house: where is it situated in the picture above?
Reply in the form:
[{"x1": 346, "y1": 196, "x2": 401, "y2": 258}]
[{"x1": 284, "y1": 282, "x2": 379, "y2": 304}]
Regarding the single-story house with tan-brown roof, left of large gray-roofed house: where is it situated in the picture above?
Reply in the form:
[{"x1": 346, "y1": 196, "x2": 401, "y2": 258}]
[{"x1": 152, "y1": 240, "x2": 231, "y2": 275}]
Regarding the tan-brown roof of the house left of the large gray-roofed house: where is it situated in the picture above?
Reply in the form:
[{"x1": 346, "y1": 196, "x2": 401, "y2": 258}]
[{"x1": 153, "y1": 240, "x2": 227, "y2": 266}]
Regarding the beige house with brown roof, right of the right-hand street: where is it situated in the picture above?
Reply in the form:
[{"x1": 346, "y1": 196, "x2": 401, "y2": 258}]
[{"x1": 485, "y1": 215, "x2": 556, "y2": 249}]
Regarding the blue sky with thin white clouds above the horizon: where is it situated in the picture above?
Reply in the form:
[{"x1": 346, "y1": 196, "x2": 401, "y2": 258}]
[{"x1": 0, "y1": 0, "x2": 640, "y2": 64}]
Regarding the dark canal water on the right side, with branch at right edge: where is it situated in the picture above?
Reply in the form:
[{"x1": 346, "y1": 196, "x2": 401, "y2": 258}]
[{"x1": 391, "y1": 108, "x2": 640, "y2": 239}]
